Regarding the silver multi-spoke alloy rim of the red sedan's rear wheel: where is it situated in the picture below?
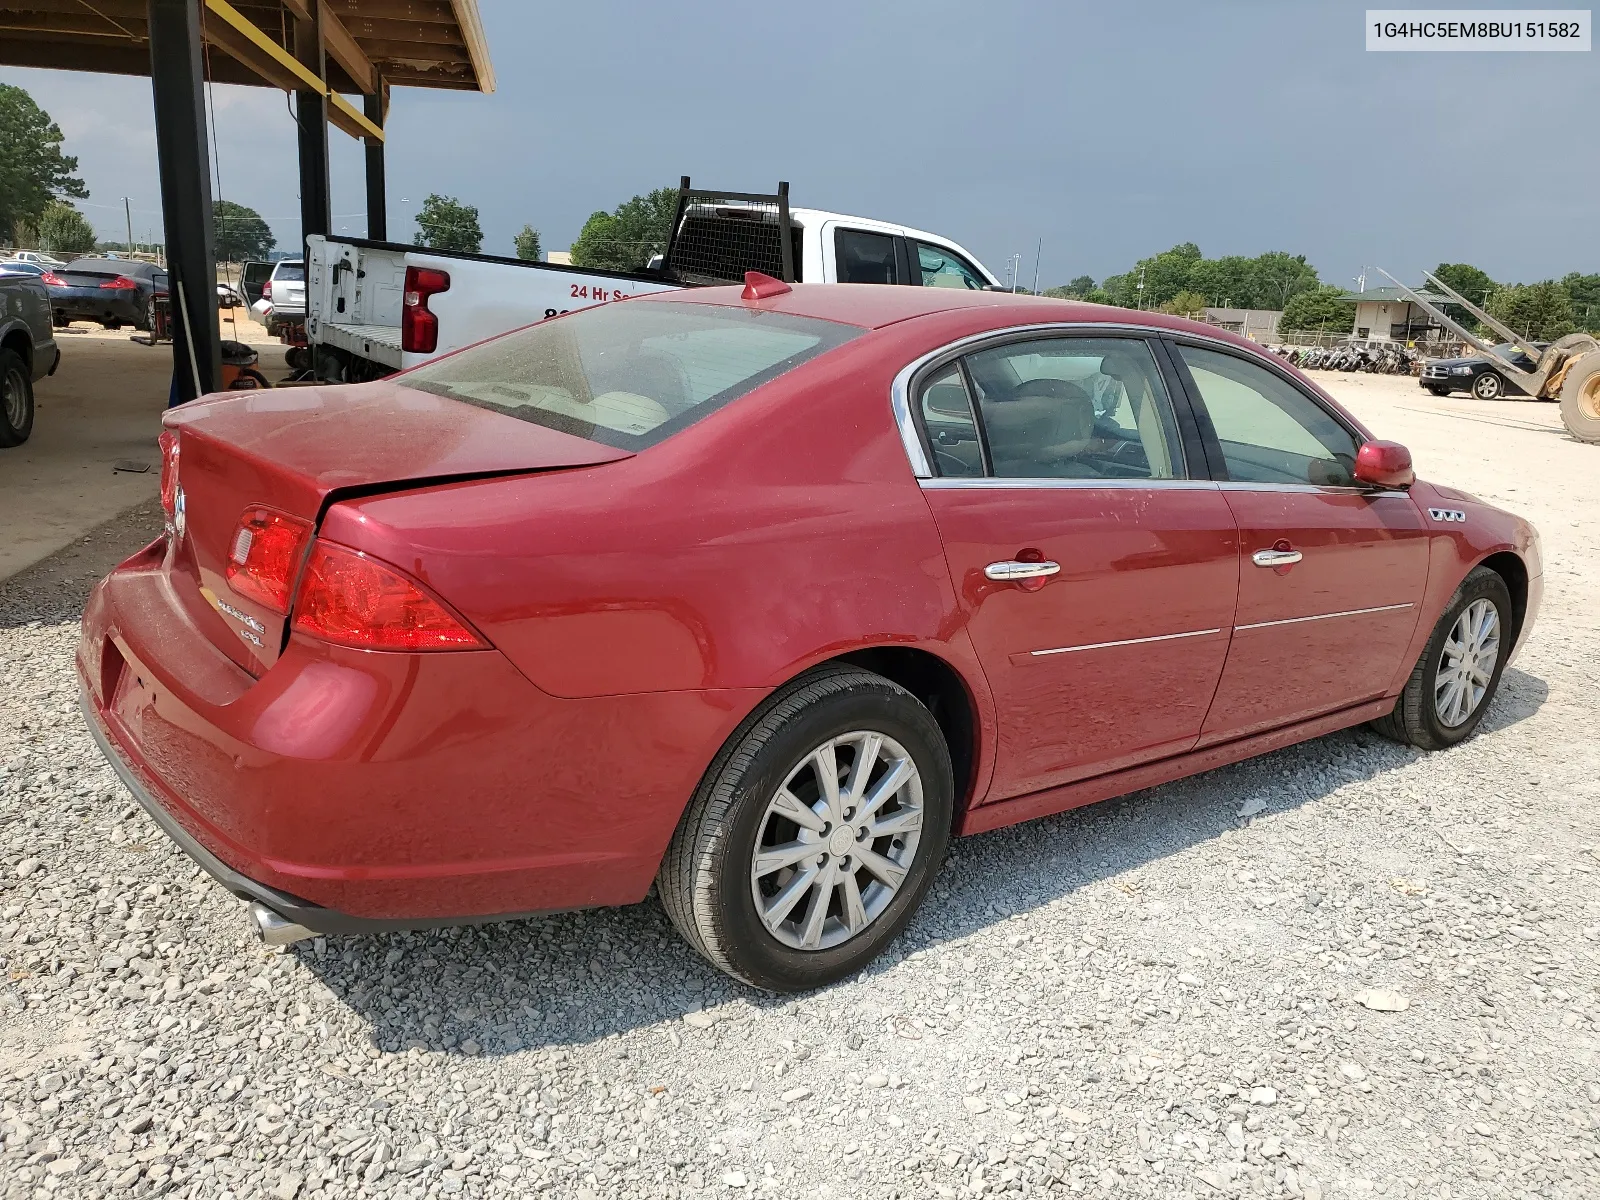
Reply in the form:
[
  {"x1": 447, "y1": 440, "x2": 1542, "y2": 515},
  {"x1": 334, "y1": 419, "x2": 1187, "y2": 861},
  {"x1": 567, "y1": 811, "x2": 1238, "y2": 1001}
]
[{"x1": 750, "y1": 730, "x2": 923, "y2": 950}]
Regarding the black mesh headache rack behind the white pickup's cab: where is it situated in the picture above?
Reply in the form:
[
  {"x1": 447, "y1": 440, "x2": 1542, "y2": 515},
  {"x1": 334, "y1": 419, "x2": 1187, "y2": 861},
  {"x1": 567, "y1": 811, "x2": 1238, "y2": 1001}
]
[{"x1": 666, "y1": 174, "x2": 800, "y2": 283}]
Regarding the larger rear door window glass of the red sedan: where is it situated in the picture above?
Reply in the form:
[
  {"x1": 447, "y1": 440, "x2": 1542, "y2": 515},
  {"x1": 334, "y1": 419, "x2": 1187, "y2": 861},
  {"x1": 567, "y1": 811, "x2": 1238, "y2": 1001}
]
[{"x1": 966, "y1": 338, "x2": 1184, "y2": 478}]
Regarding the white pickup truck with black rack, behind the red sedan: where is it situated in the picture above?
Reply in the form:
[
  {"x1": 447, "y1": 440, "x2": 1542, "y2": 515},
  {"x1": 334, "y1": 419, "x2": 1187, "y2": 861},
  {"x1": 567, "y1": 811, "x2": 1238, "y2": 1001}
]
[{"x1": 306, "y1": 179, "x2": 1000, "y2": 382}]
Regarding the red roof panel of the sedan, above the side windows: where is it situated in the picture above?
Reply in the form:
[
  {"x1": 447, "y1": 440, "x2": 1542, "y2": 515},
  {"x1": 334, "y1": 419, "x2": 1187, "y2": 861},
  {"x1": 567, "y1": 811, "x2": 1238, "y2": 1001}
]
[{"x1": 643, "y1": 283, "x2": 1261, "y2": 340}]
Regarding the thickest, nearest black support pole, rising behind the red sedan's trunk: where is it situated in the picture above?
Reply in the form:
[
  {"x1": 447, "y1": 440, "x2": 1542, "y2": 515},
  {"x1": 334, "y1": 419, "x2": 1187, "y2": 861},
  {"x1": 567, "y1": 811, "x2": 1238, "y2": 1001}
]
[{"x1": 149, "y1": 0, "x2": 222, "y2": 400}]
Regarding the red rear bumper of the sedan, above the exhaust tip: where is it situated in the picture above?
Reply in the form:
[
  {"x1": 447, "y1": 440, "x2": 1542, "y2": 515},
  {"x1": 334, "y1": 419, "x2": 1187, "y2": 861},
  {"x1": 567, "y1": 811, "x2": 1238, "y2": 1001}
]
[{"x1": 77, "y1": 539, "x2": 746, "y2": 933}]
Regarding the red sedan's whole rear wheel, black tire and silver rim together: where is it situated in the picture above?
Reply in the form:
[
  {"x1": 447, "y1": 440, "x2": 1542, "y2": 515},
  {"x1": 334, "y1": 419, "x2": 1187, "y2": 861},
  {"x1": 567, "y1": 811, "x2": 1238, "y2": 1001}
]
[{"x1": 656, "y1": 667, "x2": 954, "y2": 992}]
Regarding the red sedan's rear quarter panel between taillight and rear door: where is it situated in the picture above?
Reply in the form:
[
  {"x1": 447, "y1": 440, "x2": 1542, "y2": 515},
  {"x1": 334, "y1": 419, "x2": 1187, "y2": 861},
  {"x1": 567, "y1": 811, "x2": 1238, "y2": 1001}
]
[{"x1": 323, "y1": 338, "x2": 978, "y2": 702}]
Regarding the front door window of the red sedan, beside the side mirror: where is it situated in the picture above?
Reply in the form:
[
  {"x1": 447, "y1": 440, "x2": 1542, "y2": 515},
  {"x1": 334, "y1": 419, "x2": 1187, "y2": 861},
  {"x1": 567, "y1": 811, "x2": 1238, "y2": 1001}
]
[{"x1": 1178, "y1": 346, "x2": 1358, "y2": 488}]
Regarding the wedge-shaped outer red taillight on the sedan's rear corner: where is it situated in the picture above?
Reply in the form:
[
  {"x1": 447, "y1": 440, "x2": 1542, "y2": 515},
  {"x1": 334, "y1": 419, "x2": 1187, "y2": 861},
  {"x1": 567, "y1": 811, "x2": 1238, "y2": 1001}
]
[{"x1": 294, "y1": 541, "x2": 483, "y2": 650}]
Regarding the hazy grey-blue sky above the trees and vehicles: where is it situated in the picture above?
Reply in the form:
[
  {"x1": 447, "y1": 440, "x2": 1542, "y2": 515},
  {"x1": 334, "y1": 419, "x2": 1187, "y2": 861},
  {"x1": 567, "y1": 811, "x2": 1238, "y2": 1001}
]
[{"x1": 0, "y1": 0, "x2": 1600, "y2": 286}]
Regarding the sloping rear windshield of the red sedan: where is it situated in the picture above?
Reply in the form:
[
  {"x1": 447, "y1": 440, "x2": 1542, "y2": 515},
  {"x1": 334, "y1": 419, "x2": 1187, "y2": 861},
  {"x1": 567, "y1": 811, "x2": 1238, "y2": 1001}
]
[{"x1": 406, "y1": 301, "x2": 866, "y2": 450}]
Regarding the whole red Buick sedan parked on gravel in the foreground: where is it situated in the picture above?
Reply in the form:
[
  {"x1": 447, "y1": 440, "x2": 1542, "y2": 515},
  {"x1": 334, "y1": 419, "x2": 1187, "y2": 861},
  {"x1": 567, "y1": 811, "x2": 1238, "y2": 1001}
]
[{"x1": 78, "y1": 278, "x2": 1541, "y2": 990}]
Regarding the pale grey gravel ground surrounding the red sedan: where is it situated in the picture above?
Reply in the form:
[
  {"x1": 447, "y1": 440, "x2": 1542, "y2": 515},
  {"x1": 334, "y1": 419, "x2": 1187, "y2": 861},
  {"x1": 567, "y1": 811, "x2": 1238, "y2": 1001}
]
[{"x1": 0, "y1": 376, "x2": 1600, "y2": 1198}]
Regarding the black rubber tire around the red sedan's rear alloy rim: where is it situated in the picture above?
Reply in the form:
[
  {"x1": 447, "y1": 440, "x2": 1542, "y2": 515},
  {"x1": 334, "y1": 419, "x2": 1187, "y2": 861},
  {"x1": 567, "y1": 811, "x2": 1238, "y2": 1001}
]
[{"x1": 656, "y1": 667, "x2": 954, "y2": 992}]
